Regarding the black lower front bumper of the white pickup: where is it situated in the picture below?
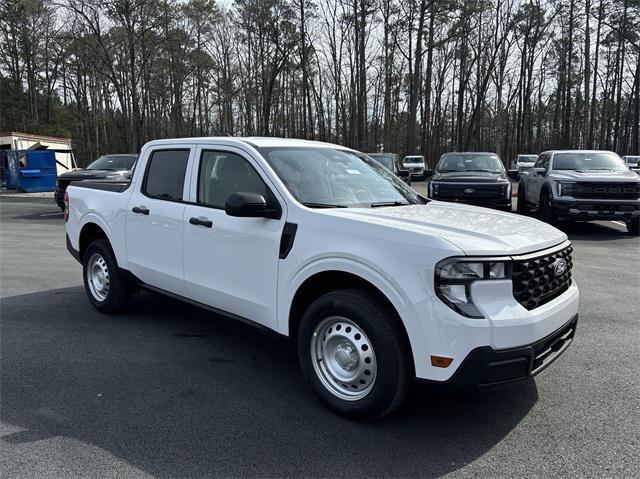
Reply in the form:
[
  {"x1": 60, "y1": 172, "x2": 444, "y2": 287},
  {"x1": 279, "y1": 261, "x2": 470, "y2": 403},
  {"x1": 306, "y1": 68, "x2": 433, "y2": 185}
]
[{"x1": 423, "y1": 314, "x2": 578, "y2": 389}]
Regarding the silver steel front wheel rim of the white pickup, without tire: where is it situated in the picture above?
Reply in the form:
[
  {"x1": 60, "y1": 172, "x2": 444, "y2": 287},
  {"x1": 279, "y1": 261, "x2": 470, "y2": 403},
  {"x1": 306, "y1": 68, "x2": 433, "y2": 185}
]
[{"x1": 311, "y1": 316, "x2": 377, "y2": 401}]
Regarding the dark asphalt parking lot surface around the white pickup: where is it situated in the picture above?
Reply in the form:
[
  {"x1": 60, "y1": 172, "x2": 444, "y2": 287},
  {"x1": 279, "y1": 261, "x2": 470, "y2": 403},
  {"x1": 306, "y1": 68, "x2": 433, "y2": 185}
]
[{"x1": 0, "y1": 192, "x2": 640, "y2": 478}]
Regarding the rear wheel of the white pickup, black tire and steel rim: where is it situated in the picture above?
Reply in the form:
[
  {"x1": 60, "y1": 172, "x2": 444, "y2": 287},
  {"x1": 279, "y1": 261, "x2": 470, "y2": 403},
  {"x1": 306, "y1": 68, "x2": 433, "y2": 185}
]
[{"x1": 82, "y1": 239, "x2": 133, "y2": 314}]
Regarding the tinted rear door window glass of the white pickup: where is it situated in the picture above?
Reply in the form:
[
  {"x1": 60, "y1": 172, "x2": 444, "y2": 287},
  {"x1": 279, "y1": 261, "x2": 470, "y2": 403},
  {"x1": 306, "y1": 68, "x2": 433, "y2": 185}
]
[{"x1": 142, "y1": 150, "x2": 189, "y2": 201}]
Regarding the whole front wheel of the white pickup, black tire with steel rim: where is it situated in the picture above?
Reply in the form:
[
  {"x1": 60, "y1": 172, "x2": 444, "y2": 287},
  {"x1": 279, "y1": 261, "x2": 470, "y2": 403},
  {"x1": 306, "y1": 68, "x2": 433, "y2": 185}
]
[{"x1": 298, "y1": 290, "x2": 412, "y2": 420}]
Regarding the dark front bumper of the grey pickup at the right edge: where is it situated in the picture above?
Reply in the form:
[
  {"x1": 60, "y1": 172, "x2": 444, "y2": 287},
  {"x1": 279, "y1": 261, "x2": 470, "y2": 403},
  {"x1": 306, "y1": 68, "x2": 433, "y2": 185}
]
[{"x1": 551, "y1": 198, "x2": 640, "y2": 221}]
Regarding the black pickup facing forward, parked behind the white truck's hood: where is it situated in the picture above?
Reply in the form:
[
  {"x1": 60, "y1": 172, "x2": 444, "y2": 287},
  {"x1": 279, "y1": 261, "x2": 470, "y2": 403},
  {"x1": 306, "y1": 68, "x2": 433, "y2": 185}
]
[{"x1": 428, "y1": 152, "x2": 511, "y2": 211}]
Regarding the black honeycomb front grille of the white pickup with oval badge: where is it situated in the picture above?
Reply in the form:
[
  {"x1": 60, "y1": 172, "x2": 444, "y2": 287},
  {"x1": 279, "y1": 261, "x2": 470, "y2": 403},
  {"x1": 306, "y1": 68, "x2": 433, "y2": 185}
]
[{"x1": 512, "y1": 246, "x2": 573, "y2": 310}]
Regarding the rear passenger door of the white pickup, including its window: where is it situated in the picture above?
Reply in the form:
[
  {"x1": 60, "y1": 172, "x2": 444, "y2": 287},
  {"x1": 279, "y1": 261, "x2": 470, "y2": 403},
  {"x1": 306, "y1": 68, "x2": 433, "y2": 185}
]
[{"x1": 126, "y1": 145, "x2": 195, "y2": 296}]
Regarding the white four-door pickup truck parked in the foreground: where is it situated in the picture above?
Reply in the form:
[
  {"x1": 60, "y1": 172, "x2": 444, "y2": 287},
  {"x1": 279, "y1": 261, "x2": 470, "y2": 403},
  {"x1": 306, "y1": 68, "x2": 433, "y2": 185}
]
[{"x1": 65, "y1": 138, "x2": 578, "y2": 419}]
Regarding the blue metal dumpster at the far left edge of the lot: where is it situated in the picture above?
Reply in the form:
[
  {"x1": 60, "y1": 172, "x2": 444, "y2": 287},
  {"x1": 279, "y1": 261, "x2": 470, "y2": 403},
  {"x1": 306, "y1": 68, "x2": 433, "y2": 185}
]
[{"x1": 2, "y1": 150, "x2": 58, "y2": 193}]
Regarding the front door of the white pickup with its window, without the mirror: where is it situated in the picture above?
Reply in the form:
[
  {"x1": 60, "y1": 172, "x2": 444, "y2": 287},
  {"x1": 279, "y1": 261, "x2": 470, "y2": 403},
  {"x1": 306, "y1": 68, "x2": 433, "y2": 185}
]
[{"x1": 183, "y1": 147, "x2": 285, "y2": 328}]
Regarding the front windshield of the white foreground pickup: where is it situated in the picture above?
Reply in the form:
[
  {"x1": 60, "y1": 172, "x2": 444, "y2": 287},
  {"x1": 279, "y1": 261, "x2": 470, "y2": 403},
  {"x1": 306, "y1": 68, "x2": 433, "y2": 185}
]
[{"x1": 260, "y1": 147, "x2": 424, "y2": 208}]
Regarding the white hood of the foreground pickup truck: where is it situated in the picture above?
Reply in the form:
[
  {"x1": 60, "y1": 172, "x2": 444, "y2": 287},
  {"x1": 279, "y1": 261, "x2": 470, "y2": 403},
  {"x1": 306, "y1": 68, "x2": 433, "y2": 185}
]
[{"x1": 324, "y1": 201, "x2": 567, "y2": 255}]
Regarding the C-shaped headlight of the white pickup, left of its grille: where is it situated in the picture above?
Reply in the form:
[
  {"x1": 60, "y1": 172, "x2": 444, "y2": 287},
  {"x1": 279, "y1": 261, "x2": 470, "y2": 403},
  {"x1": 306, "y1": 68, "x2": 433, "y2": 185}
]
[{"x1": 434, "y1": 258, "x2": 511, "y2": 318}]
